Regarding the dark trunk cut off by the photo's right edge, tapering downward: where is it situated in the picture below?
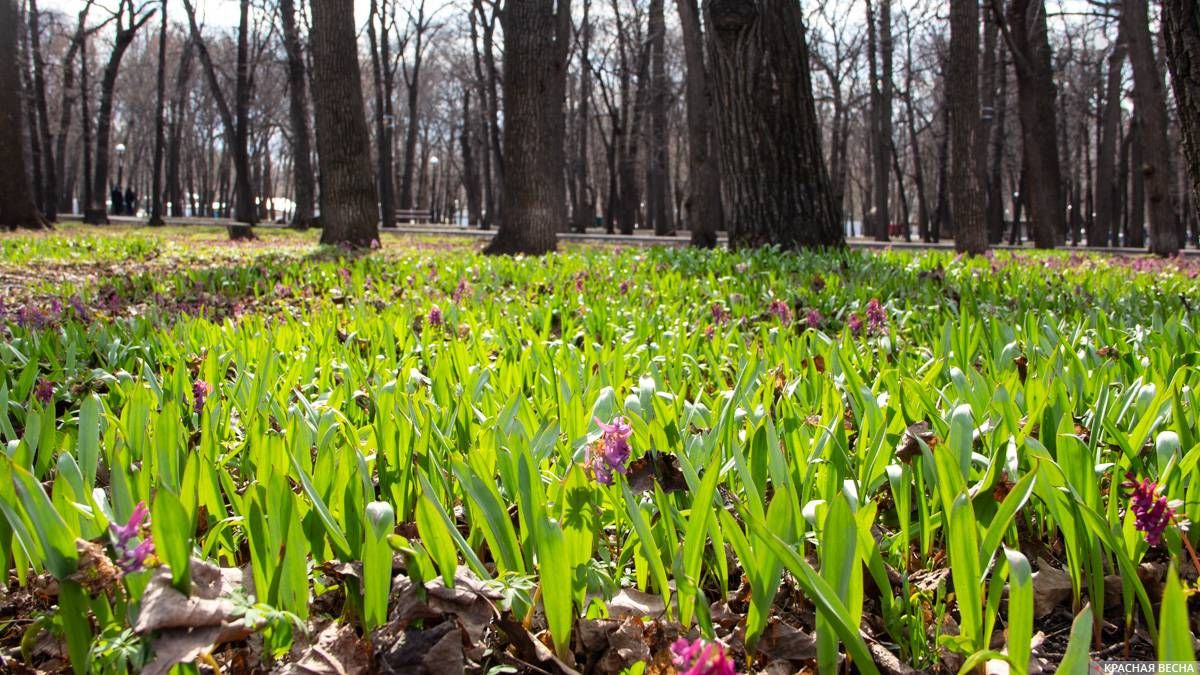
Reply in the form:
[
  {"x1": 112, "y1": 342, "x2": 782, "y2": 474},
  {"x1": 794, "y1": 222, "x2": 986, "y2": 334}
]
[{"x1": 1163, "y1": 0, "x2": 1200, "y2": 220}]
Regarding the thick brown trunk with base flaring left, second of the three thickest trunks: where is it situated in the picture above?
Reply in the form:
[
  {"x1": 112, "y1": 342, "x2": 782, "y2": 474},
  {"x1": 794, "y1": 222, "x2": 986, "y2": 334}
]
[{"x1": 485, "y1": 0, "x2": 571, "y2": 255}]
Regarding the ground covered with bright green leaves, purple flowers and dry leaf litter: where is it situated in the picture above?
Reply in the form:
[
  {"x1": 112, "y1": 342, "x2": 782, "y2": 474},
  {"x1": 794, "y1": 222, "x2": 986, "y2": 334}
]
[{"x1": 0, "y1": 227, "x2": 1200, "y2": 675}]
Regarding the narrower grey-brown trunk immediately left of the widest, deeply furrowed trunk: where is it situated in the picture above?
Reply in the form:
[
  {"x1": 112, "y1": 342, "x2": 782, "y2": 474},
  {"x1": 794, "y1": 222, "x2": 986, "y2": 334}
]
[{"x1": 676, "y1": 0, "x2": 722, "y2": 249}]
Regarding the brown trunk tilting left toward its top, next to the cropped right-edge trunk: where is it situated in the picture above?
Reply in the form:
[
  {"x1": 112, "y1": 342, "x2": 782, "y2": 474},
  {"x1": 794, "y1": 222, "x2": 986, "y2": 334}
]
[{"x1": 1121, "y1": 0, "x2": 1180, "y2": 256}]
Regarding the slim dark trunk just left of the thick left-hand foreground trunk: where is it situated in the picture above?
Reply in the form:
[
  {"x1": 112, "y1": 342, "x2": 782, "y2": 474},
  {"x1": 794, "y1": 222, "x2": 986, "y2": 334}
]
[{"x1": 280, "y1": 0, "x2": 317, "y2": 229}]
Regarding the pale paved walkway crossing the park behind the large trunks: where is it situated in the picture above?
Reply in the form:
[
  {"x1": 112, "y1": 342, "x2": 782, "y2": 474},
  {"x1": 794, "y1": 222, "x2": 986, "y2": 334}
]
[{"x1": 72, "y1": 215, "x2": 1200, "y2": 257}]
